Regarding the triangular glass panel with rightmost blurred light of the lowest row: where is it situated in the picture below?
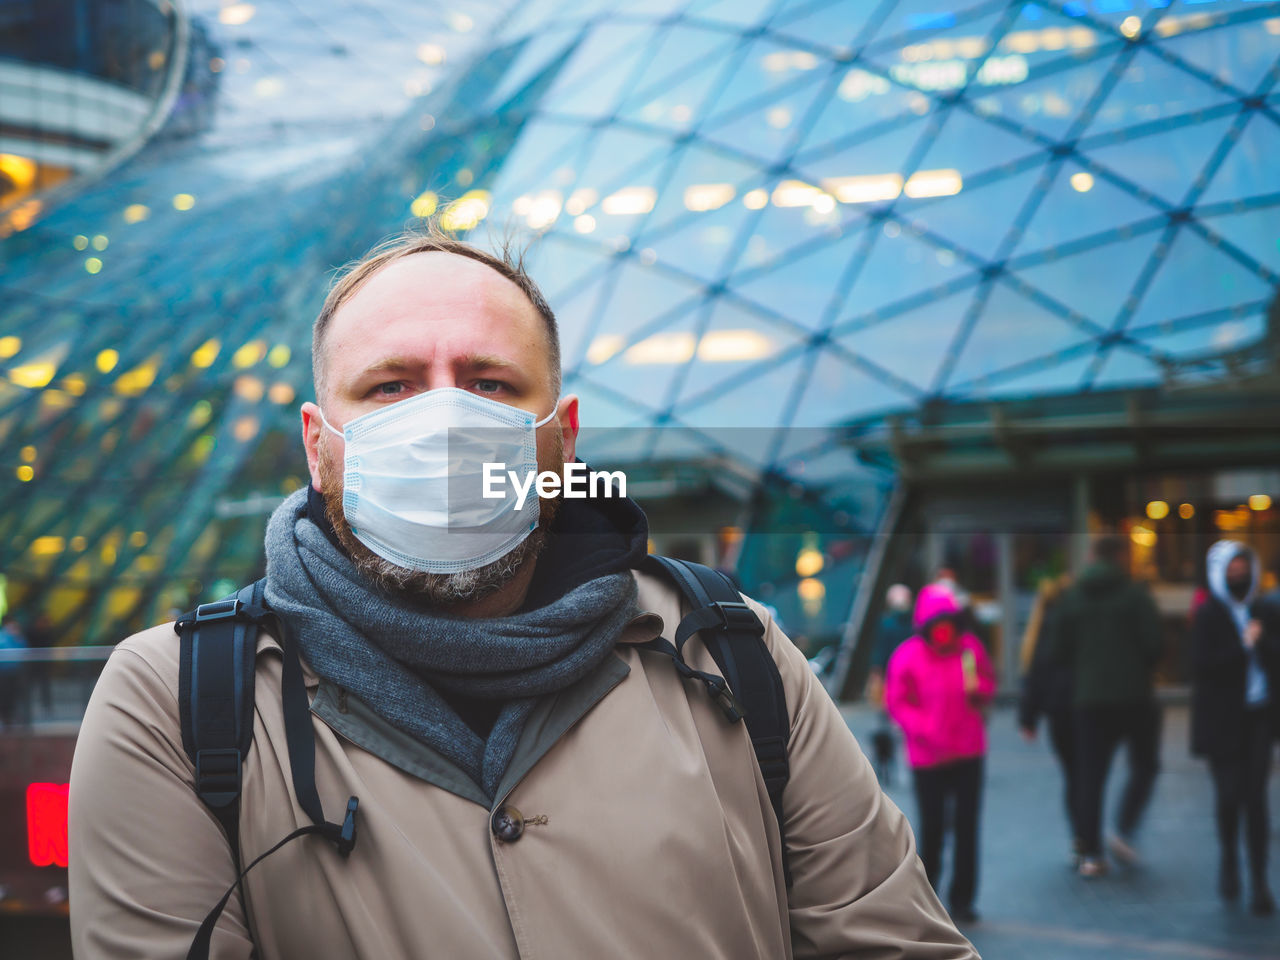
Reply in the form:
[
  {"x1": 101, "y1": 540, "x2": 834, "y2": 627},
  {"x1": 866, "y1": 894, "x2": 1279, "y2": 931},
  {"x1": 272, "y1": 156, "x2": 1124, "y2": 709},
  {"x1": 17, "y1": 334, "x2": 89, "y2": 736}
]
[{"x1": 677, "y1": 298, "x2": 804, "y2": 407}]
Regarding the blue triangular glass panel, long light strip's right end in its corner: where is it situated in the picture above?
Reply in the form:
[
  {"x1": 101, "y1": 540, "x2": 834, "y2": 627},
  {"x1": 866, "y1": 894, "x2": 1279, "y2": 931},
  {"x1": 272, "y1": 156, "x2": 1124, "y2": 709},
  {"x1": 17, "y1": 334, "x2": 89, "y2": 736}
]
[{"x1": 896, "y1": 169, "x2": 1041, "y2": 257}]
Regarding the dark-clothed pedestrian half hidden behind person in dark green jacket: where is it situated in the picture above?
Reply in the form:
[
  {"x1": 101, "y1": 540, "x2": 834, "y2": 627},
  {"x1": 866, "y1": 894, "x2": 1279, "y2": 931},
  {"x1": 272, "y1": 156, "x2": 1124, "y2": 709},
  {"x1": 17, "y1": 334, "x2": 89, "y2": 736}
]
[{"x1": 1018, "y1": 573, "x2": 1080, "y2": 867}]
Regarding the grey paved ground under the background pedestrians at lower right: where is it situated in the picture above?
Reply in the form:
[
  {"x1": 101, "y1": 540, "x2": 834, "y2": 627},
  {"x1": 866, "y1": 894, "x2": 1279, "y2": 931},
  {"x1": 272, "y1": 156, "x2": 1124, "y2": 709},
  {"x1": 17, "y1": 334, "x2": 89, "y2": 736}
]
[{"x1": 847, "y1": 707, "x2": 1280, "y2": 960}]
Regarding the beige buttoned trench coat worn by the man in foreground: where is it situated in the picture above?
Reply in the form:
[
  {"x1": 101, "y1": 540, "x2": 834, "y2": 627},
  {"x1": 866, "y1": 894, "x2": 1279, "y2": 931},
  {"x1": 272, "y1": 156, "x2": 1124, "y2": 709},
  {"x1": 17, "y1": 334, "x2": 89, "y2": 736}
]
[{"x1": 70, "y1": 573, "x2": 977, "y2": 960}]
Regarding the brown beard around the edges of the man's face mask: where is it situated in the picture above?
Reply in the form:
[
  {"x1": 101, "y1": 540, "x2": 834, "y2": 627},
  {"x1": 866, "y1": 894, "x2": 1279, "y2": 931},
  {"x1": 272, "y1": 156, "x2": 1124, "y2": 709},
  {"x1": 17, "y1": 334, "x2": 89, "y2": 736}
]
[{"x1": 319, "y1": 430, "x2": 564, "y2": 607}]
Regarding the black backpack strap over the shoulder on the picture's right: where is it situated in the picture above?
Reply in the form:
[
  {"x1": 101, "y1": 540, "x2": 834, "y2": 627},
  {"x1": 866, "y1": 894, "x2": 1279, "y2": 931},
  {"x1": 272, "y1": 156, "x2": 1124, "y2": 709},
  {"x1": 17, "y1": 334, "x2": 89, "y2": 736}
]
[{"x1": 645, "y1": 556, "x2": 791, "y2": 887}]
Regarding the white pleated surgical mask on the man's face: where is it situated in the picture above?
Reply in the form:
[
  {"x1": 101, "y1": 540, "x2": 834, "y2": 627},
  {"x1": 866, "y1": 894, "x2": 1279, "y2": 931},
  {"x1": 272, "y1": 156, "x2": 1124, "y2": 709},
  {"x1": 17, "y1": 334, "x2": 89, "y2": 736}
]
[{"x1": 320, "y1": 387, "x2": 556, "y2": 573}]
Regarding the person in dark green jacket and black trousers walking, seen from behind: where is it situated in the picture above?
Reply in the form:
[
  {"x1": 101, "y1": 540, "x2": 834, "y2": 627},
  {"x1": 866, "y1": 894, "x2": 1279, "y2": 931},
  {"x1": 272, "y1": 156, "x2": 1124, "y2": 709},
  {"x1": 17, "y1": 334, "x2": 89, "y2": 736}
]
[{"x1": 1048, "y1": 536, "x2": 1162, "y2": 877}]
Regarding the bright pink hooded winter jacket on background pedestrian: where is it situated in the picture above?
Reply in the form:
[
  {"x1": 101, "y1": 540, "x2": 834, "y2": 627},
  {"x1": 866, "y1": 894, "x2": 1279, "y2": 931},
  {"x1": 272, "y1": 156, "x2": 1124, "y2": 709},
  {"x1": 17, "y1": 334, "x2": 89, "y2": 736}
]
[{"x1": 884, "y1": 585, "x2": 996, "y2": 767}]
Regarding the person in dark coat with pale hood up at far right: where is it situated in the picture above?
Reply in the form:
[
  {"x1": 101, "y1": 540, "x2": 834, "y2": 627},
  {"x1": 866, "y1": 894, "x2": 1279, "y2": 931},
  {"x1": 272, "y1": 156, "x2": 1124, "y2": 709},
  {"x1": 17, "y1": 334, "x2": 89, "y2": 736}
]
[{"x1": 1192, "y1": 540, "x2": 1280, "y2": 915}]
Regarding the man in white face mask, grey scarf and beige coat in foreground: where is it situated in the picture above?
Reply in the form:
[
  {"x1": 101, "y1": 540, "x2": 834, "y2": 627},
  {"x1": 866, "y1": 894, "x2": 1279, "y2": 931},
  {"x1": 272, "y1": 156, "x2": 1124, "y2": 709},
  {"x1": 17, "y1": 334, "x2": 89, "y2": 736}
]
[{"x1": 69, "y1": 233, "x2": 977, "y2": 960}]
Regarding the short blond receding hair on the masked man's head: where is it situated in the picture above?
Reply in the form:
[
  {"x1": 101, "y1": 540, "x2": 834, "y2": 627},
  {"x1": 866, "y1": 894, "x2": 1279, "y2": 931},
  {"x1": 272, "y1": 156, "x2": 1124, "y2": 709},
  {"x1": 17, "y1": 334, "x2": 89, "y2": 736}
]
[{"x1": 311, "y1": 219, "x2": 561, "y2": 399}]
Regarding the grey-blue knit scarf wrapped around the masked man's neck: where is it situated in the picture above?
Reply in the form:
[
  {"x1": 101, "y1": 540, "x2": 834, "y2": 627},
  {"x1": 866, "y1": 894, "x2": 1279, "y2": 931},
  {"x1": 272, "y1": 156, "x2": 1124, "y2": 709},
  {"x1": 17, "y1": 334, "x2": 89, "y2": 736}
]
[{"x1": 266, "y1": 489, "x2": 637, "y2": 799}]
